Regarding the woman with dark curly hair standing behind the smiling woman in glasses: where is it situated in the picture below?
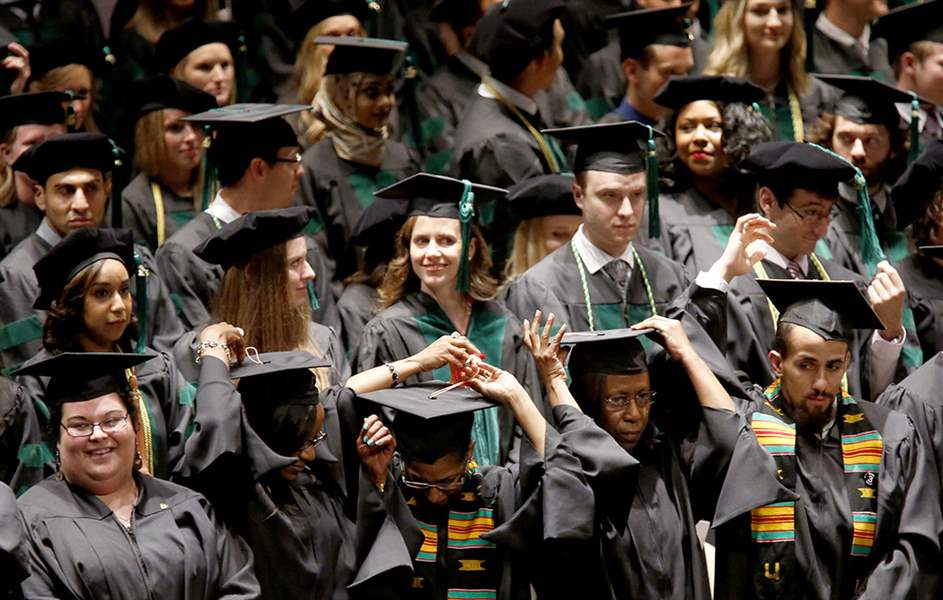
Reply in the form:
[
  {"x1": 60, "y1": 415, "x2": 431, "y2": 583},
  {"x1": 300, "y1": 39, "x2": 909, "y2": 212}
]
[{"x1": 17, "y1": 228, "x2": 227, "y2": 477}]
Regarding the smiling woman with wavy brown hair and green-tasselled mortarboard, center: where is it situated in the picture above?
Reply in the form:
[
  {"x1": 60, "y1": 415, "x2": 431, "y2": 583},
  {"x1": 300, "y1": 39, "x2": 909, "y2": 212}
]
[{"x1": 354, "y1": 173, "x2": 541, "y2": 466}]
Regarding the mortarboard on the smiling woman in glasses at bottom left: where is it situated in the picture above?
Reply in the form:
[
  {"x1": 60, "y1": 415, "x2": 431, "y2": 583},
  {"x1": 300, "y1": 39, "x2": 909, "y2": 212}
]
[{"x1": 14, "y1": 352, "x2": 158, "y2": 405}]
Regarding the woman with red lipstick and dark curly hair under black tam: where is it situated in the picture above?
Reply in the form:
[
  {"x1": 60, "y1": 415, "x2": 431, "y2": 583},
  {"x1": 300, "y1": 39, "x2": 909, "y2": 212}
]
[{"x1": 655, "y1": 75, "x2": 772, "y2": 277}]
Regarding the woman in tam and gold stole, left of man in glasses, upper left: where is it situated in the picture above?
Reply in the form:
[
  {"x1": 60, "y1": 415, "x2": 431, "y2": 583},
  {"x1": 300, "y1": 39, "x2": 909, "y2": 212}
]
[{"x1": 121, "y1": 75, "x2": 216, "y2": 252}]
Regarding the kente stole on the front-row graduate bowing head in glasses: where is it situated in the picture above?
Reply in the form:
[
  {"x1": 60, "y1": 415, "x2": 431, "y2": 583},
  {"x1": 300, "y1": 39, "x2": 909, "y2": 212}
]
[{"x1": 407, "y1": 462, "x2": 502, "y2": 600}]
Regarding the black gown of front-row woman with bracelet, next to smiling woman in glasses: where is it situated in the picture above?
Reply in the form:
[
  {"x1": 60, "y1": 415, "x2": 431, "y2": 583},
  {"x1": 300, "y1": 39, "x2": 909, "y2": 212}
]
[{"x1": 177, "y1": 358, "x2": 354, "y2": 600}]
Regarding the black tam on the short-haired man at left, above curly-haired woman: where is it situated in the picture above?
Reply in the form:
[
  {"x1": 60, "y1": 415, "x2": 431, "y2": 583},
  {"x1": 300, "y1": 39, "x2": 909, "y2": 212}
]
[{"x1": 13, "y1": 132, "x2": 115, "y2": 186}]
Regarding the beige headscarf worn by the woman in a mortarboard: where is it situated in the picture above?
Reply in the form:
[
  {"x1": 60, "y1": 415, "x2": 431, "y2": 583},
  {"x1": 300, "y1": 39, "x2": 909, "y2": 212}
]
[{"x1": 307, "y1": 73, "x2": 390, "y2": 167}]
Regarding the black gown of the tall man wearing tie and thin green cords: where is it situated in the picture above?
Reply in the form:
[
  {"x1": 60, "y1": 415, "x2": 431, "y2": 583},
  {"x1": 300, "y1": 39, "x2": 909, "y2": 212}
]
[{"x1": 505, "y1": 244, "x2": 688, "y2": 331}]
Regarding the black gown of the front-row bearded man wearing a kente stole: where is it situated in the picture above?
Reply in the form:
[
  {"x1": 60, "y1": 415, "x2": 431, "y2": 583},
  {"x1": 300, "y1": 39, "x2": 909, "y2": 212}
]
[{"x1": 713, "y1": 388, "x2": 943, "y2": 600}]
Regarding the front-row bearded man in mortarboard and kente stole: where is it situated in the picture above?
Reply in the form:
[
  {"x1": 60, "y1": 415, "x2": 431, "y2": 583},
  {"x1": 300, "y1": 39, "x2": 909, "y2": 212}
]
[{"x1": 713, "y1": 280, "x2": 941, "y2": 600}]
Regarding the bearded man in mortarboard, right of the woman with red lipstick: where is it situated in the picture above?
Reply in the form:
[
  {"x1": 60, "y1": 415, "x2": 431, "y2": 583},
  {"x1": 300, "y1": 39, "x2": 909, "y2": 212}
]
[{"x1": 812, "y1": 75, "x2": 911, "y2": 277}]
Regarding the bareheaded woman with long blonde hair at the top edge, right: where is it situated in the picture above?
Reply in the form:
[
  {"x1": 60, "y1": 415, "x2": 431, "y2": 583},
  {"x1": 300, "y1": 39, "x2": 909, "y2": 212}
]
[{"x1": 704, "y1": 0, "x2": 827, "y2": 142}]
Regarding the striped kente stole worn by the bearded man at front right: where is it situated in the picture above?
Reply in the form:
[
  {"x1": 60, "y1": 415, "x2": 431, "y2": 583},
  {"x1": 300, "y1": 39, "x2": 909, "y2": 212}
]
[{"x1": 750, "y1": 379, "x2": 884, "y2": 582}]
